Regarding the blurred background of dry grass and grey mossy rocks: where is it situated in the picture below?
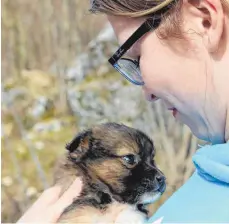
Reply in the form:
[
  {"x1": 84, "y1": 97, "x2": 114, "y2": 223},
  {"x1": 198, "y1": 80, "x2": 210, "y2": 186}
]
[{"x1": 1, "y1": 0, "x2": 205, "y2": 222}]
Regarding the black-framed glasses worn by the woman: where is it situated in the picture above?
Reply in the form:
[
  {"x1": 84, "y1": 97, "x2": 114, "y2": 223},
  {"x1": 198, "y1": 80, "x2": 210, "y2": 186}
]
[{"x1": 108, "y1": 1, "x2": 175, "y2": 86}]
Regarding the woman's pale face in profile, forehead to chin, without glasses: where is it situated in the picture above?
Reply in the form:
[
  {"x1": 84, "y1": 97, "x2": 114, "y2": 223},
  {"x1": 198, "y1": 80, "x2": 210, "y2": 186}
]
[{"x1": 108, "y1": 13, "x2": 226, "y2": 143}]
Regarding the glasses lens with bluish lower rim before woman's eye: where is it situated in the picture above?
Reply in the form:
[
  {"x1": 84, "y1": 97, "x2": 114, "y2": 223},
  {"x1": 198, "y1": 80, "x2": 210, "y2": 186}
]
[{"x1": 114, "y1": 58, "x2": 144, "y2": 85}]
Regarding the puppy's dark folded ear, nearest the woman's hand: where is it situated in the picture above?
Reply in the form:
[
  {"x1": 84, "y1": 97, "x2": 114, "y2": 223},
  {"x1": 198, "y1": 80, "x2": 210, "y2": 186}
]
[{"x1": 66, "y1": 130, "x2": 92, "y2": 162}]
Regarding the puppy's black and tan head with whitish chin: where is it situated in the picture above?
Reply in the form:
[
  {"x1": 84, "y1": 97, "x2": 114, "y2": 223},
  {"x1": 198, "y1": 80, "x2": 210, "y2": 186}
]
[{"x1": 67, "y1": 123, "x2": 165, "y2": 207}]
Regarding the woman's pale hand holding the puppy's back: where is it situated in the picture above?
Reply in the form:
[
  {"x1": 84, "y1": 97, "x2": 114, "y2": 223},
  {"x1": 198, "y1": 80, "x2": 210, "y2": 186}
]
[{"x1": 17, "y1": 179, "x2": 82, "y2": 223}]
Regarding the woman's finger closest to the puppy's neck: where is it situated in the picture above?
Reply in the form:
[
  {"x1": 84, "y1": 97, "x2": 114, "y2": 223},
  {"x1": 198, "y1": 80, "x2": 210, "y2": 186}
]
[{"x1": 55, "y1": 178, "x2": 82, "y2": 211}]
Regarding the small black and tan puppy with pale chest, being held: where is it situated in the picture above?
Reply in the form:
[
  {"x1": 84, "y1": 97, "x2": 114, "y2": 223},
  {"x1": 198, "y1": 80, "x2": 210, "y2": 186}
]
[{"x1": 55, "y1": 123, "x2": 165, "y2": 223}]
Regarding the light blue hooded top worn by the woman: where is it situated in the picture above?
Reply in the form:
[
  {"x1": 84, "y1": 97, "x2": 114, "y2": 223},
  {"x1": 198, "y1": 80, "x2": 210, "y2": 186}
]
[{"x1": 148, "y1": 143, "x2": 229, "y2": 223}]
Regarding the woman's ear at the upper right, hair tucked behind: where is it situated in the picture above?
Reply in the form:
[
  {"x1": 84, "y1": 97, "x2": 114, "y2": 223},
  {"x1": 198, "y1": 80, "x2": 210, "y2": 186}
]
[{"x1": 184, "y1": 0, "x2": 225, "y2": 52}]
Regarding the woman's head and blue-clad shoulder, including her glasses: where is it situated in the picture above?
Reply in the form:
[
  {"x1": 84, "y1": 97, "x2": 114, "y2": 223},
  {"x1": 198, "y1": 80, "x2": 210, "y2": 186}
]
[{"x1": 17, "y1": 0, "x2": 229, "y2": 223}]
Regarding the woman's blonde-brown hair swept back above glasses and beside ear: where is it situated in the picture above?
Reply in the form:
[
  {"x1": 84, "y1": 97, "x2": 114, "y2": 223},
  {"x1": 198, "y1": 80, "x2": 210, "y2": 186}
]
[{"x1": 90, "y1": 0, "x2": 229, "y2": 40}]
